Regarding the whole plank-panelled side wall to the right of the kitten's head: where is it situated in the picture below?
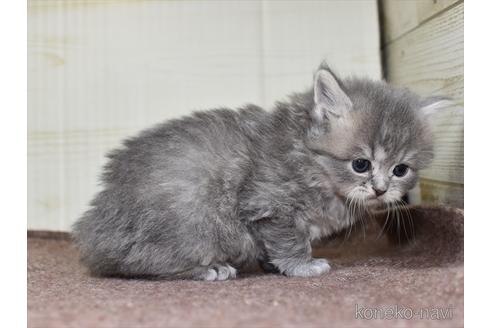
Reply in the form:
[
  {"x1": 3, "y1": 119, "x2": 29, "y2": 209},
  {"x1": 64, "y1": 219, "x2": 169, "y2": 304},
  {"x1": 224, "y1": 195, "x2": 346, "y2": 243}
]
[{"x1": 380, "y1": 0, "x2": 464, "y2": 207}]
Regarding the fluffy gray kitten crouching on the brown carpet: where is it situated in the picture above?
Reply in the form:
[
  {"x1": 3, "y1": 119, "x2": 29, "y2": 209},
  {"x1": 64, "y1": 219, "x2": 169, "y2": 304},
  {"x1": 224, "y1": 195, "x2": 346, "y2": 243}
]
[{"x1": 73, "y1": 65, "x2": 444, "y2": 280}]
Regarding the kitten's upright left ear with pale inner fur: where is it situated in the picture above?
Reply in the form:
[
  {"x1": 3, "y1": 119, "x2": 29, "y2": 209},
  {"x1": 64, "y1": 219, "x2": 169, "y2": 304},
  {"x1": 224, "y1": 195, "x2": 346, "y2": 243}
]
[{"x1": 313, "y1": 68, "x2": 353, "y2": 120}]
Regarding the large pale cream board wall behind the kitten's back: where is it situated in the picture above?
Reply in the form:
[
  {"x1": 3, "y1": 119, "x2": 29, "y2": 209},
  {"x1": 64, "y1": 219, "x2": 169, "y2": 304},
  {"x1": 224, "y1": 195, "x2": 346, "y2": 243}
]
[{"x1": 28, "y1": 0, "x2": 381, "y2": 230}]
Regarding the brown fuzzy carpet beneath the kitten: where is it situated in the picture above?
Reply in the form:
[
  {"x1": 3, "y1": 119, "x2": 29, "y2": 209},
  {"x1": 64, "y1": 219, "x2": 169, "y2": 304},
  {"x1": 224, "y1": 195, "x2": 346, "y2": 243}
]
[{"x1": 27, "y1": 208, "x2": 464, "y2": 328}]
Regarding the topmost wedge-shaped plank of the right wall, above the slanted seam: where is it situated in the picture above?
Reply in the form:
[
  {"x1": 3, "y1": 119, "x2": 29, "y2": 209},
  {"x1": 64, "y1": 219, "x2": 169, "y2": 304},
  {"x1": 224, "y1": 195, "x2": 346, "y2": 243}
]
[{"x1": 381, "y1": 0, "x2": 462, "y2": 44}]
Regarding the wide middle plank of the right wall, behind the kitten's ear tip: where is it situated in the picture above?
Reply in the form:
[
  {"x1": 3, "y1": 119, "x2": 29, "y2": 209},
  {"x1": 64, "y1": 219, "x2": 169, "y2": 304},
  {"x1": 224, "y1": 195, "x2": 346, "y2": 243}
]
[{"x1": 385, "y1": 3, "x2": 464, "y2": 203}]
